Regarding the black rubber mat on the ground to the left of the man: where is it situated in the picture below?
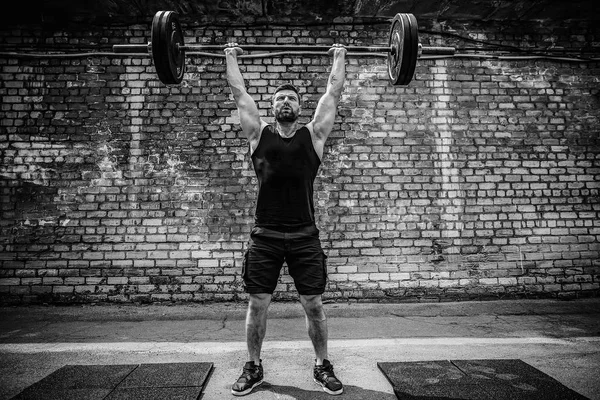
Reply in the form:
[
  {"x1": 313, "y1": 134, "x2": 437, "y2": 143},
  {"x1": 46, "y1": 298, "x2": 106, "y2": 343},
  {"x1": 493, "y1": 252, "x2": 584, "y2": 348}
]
[{"x1": 12, "y1": 363, "x2": 213, "y2": 400}]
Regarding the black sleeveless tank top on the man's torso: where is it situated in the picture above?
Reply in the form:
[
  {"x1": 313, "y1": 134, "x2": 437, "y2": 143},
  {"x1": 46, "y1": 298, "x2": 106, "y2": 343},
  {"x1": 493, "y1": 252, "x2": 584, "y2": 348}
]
[{"x1": 252, "y1": 125, "x2": 321, "y2": 232}]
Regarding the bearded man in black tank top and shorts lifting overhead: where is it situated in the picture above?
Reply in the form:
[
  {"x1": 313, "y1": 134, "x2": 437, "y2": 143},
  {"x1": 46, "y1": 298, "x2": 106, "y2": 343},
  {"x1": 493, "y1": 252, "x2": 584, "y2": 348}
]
[{"x1": 225, "y1": 43, "x2": 346, "y2": 396}]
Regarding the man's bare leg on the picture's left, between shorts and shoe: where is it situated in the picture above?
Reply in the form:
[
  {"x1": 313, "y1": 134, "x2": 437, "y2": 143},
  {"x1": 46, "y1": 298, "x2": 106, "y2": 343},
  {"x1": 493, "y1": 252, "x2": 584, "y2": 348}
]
[{"x1": 246, "y1": 293, "x2": 272, "y2": 365}]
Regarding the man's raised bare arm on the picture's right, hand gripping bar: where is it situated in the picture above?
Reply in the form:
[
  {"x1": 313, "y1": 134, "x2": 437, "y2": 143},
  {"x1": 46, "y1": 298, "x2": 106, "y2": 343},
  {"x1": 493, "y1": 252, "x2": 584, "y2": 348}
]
[{"x1": 307, "y1": 45, "x2": 346, "y2": 159}]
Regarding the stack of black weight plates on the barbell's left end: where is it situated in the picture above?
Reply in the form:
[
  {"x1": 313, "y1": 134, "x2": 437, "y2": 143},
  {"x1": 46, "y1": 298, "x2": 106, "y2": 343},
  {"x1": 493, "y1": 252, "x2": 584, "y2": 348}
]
[{"x1": 152, "y1": 11, "x2": 185, "y2": 85}]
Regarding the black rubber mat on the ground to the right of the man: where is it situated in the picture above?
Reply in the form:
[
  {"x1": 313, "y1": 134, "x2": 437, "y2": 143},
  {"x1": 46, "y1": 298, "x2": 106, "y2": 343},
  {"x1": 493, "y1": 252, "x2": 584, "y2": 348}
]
[{"x1": 377, "y1": 360, "x2": 589, "y2": 400}]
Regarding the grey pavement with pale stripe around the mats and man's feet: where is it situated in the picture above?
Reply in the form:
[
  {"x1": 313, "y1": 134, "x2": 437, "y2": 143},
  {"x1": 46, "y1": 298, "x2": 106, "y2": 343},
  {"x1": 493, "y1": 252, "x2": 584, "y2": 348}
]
[{"x1": 0, "y1": 298, "x2": 600, "y2": 400}]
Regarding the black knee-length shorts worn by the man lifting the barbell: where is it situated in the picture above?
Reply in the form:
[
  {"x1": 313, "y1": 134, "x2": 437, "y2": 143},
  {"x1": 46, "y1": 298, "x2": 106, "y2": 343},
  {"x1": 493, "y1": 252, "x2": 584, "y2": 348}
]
[{"x1": 242, "y1": 226, "x2": 327, "y2": 295}]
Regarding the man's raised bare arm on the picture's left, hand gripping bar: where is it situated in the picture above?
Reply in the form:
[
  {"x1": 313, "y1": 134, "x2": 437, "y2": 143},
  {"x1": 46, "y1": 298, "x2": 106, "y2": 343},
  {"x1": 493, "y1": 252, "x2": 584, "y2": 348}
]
[{"x1": 225, "y1": 43, "x2": 267, "y2": 151}]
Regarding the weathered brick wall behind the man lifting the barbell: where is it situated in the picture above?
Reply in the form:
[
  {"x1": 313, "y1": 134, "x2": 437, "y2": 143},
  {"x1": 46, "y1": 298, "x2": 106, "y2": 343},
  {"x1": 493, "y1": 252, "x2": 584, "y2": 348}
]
[{"x1": 0, "y1": 15, "x2": 600, "y2": 302}]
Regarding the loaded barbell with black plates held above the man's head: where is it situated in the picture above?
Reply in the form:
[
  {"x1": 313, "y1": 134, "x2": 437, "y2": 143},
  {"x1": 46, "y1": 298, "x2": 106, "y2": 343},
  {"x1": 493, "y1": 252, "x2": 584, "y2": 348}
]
[{"x1": 113, "y1": 11, "x2": 455, "y2": 85}]
